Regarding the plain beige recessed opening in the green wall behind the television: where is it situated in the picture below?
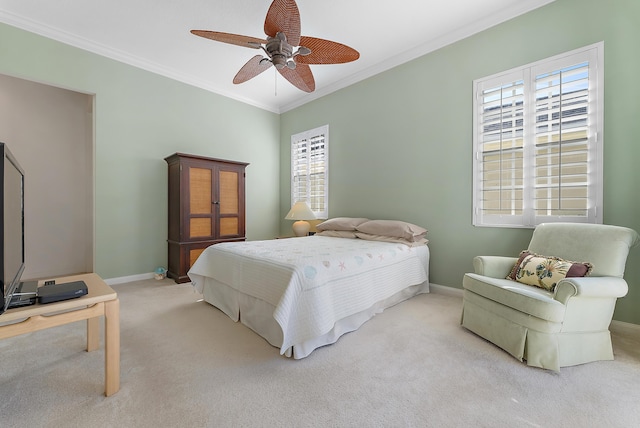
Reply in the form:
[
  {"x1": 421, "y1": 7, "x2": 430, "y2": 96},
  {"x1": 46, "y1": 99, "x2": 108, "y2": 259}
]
[{"x1": 0, "y1": 74, "x2": 95, "y2": 279}]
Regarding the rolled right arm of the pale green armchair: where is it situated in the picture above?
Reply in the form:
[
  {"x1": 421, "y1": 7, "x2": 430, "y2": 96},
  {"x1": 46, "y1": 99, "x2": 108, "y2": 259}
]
[{"x1": 553, "y1": 276, "x2": 629, "y2": 304}]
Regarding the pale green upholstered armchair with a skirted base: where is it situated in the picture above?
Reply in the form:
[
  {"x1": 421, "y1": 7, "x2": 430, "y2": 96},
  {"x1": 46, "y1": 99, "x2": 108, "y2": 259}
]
[{"x1": 462, "y1": 223, "x2": 638, "y2": 371}]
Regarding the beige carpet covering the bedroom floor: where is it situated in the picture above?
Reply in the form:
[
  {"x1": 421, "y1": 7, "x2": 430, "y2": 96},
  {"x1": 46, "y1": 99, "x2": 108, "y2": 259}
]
[{"x1": 0, "y1": 280, "x2": 640, "y2": 428}]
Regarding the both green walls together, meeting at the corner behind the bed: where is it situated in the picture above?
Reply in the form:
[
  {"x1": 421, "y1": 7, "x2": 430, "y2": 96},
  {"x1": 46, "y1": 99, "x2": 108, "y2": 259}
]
[{"x1": 0, "y1": 0, "x2": 640, "y2": 324}]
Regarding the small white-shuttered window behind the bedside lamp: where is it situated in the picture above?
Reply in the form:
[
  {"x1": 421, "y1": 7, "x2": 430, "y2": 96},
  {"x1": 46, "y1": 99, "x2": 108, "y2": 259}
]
[{"x1": 291, "y1": 125, "x2": 329, "y2": 218}]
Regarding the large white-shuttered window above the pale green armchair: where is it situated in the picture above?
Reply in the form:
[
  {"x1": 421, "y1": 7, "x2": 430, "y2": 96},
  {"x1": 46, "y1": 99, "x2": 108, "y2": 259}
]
[{"x1": 473, "y1": 42, "x2": 604, "y2": 227}]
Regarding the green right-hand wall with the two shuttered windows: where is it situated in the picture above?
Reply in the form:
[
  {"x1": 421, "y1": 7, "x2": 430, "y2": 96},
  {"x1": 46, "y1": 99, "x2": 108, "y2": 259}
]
[{"x1": 280, "y1": 0, "x2": 640, "y2": 324}]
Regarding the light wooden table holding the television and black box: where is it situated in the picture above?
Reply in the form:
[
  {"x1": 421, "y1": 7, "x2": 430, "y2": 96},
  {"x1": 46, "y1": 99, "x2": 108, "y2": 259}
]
[{"x1": 0, "y1": 273, "x2": 120, "y2": 397}]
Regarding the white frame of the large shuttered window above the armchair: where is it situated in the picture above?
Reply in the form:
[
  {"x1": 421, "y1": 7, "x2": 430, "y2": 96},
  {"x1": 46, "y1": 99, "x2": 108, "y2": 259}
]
[{"x1": 473, "y1": 42, "x2": 604, "y2": 228}]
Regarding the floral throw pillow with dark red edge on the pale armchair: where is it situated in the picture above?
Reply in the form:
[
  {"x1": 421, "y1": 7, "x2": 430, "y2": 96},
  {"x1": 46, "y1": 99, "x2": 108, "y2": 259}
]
[{"x1": 507, "y1": 250, "x2": 593, "y2": 291}]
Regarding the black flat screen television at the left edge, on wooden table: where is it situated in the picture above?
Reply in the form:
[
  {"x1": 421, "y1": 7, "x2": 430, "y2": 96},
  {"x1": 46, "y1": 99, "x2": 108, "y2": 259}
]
[{"x1": 0, "y1": 143, "x2": 25, "y2": 314}]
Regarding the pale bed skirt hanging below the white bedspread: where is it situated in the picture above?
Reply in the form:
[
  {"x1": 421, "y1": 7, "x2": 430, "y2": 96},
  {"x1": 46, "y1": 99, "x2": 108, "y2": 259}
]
[{"x1": 203, "y1": 277, "x2": 429, "y2": 359}]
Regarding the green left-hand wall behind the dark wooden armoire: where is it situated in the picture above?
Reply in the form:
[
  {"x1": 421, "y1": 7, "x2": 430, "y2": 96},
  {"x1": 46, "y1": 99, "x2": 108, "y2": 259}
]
[{"x1": 0, "y1": 24, "x2": 280, "y2": 278}]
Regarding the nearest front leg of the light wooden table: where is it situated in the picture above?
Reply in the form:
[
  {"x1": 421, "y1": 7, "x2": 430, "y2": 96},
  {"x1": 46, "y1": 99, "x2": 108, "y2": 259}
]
[{"x1": 104, "y1": 299, "x2": 120, "y2": 397}]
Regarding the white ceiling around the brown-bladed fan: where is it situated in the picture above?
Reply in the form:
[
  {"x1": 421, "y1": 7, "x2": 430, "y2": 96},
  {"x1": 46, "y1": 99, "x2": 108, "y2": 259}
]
[{"x1": 0, "y1": 0, "x2": 553, "y2": 113}]
